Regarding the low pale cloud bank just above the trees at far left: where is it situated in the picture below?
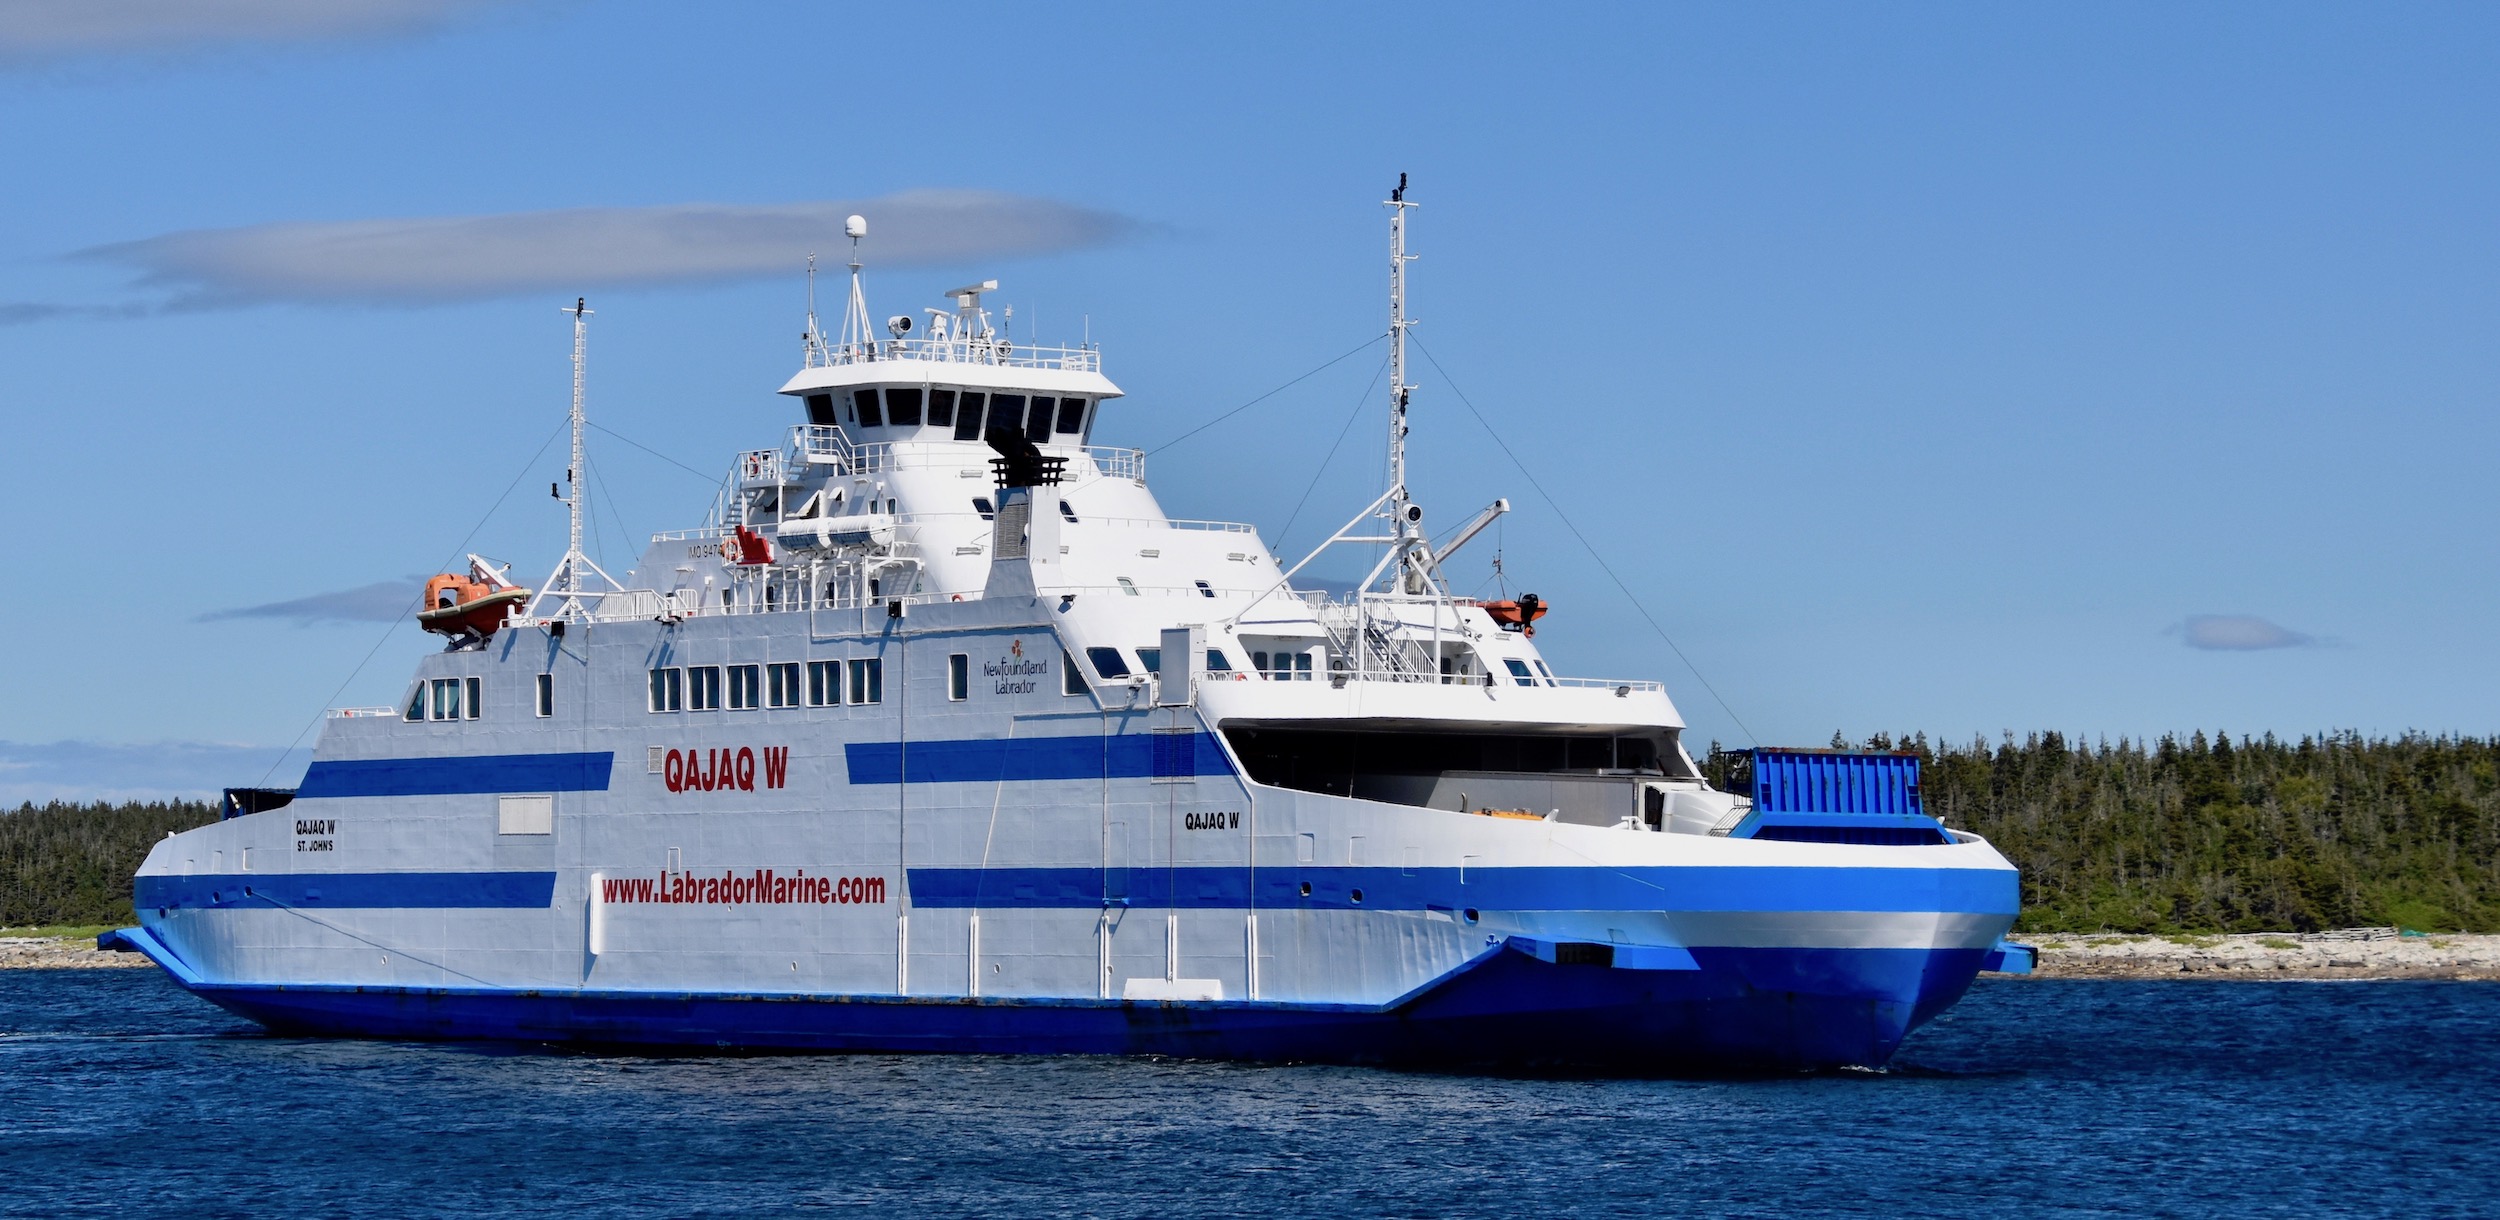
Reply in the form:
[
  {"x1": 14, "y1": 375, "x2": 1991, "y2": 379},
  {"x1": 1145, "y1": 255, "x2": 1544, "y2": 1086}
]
[{"x1": 0, "y1": 740, "x2": 308, "y2": 808}]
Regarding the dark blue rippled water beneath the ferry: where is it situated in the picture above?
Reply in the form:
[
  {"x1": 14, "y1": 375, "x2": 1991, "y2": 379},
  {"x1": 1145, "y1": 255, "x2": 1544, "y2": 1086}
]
[{"x1": 0, "y1": 970, "x2": 2500, "y2": 1218}]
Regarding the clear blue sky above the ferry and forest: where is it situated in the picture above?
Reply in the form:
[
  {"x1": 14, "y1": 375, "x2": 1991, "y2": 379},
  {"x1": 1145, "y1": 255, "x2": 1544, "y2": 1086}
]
[{"x1": 0, "y1": 0, "x2": 2500, "y2": 800}]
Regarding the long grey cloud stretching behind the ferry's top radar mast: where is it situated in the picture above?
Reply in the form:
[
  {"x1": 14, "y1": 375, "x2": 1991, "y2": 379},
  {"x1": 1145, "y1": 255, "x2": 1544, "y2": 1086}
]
[{"x1": 58, "y1": 191, "x2": 1145, "y2": 320}]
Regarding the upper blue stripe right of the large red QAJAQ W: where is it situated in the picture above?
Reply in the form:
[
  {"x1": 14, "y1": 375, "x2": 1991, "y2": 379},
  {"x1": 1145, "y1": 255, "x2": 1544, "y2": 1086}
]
[{"x1": 843, "y1": 733, "x2": 1233, "y2": 783}]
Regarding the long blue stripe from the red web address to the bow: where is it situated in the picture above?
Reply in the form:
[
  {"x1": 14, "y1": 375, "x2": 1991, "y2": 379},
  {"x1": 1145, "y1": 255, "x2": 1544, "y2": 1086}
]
[{"x1": 908, "y1": 865, "x2": 2023, "y2": 915}]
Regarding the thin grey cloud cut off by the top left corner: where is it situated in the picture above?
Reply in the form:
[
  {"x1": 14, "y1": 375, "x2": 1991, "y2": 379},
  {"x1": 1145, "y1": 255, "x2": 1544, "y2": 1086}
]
[{"x1": 0, "y1": 0, "x2": 502, "y2": 63}]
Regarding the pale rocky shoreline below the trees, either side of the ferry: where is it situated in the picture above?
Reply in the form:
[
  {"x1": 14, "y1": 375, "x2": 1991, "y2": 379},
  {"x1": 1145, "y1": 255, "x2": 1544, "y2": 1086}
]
[{"x1": 0, "y1": 933, "x2": 2500, "y2": 980}]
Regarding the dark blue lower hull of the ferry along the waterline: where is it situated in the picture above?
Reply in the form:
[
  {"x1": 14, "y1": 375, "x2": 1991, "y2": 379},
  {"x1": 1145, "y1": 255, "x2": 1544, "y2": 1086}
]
[{"x1": 143, "y1": 943, "x2": 1980, "y2": 1075}]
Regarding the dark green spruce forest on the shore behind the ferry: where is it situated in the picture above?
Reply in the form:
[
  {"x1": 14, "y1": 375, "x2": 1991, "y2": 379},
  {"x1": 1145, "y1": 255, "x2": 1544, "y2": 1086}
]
[{"x1": 0, "y1": 733, "x2": 2500, "y2": 933}]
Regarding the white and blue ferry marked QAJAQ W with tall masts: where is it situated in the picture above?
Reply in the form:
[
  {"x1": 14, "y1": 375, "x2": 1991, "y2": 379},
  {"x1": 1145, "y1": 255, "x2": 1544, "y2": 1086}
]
[{"x1": 103, "y1": 180, "x2": 2028, "y2": 1073}]
